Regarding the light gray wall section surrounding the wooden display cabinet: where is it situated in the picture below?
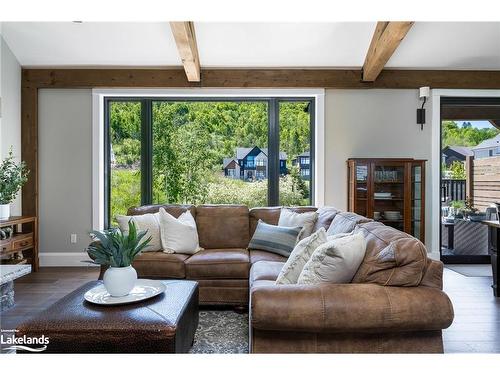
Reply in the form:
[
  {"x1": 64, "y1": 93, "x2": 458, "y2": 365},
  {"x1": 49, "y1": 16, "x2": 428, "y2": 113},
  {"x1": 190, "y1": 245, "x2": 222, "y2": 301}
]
[{"x1": 325, "y1": 90, "x2": 432, "y2": 250}]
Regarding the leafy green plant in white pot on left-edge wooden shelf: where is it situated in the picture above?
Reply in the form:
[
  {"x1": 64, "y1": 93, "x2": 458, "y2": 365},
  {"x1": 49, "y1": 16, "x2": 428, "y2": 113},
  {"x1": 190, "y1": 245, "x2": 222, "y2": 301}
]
[{"x1": 0, "y1": 147, "x2": 29, "y2": 220}]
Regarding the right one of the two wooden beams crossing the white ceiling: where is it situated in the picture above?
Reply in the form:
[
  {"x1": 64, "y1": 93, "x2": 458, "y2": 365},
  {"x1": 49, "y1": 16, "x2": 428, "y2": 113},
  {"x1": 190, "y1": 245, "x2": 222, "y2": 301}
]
[{"x1": 363, "y1": 22, "x2": 413, "y2": 82}]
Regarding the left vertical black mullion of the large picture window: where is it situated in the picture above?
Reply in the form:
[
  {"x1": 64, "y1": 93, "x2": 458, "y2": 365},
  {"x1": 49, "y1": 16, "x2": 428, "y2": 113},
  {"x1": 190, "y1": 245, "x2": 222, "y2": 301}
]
[{"x1": 141, "y1": 99, "x2": 153, "y2": 205}]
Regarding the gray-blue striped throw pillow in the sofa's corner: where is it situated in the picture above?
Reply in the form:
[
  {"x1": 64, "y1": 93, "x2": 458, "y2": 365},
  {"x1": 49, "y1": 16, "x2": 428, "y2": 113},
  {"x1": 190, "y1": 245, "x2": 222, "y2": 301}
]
[{"x1": 248, "y1": 220, "x2": 302, "y2": 257}]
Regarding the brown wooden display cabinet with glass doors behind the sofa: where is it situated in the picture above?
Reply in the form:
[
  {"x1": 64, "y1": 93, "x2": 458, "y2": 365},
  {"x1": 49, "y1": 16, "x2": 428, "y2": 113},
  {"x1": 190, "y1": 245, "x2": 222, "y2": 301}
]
[{"x1": 347, "y1": 158, "x2": 426, "y2": 242}]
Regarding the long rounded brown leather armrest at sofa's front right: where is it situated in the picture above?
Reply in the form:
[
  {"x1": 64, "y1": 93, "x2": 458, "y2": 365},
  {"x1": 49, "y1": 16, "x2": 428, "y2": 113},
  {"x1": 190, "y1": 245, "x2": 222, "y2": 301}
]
[{"x1": 250, "y1": 284, "x2": 453, "y2": 333}]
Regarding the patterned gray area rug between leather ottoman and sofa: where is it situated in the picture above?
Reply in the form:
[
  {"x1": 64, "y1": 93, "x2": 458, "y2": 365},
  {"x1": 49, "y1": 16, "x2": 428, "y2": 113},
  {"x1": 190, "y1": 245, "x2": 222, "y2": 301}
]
[{"x1": 190, "y1": 310, "x2": 248, "y2": 354}]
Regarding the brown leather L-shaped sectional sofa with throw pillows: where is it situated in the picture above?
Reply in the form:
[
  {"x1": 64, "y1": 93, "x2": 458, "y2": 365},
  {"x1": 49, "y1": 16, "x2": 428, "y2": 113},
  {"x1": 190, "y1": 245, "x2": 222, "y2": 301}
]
[{"x1": 100, "y1": 205, "x2": 453, "y2": 353}]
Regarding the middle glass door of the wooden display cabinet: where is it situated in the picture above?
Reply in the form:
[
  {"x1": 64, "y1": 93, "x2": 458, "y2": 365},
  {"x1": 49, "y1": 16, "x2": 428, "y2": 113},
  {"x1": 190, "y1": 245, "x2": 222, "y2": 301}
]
[{"x1": 373, "y1": 164, "x2": 405, "y2": 231}]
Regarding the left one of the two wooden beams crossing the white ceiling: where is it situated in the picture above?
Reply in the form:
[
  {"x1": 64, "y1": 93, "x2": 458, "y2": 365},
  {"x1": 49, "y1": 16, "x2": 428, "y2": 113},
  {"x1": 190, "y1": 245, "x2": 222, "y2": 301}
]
[{"x1": 170, "y1": 21, "x2": 201, "y2": 82}]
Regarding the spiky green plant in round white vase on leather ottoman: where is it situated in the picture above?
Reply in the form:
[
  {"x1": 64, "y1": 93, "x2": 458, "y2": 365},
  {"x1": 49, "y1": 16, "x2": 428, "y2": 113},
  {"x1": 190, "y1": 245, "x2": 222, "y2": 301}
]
[{"x1": 87, "y1": 220, "x2": 151, "y2": 297}]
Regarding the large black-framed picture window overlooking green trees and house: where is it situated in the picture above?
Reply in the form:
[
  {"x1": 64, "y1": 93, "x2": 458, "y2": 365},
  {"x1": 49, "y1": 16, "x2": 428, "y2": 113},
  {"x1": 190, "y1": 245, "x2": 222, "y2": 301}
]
[{"x1": 104, "y1": 97, "x2": 315, "y2": 226}]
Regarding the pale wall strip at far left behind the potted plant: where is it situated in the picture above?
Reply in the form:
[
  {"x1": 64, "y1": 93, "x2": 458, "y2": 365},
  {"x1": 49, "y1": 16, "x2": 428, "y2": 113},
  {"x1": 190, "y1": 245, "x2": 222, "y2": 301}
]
[{"x1": 0, "y1": 37, "x2": 21, "y2": 215}]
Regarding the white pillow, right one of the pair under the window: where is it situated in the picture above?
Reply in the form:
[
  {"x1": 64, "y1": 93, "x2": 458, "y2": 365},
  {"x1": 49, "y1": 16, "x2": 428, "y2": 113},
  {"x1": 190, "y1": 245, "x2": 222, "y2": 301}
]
[{"x1": 160, "y1": 207, "x2": 202, "y2": 254}]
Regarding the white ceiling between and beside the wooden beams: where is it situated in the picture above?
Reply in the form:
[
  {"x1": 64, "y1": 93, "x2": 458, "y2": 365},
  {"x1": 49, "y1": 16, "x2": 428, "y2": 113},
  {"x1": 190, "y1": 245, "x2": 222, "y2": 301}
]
[{"x1": 2, "y1": 22, "x2": 500, "y2": 69}]
